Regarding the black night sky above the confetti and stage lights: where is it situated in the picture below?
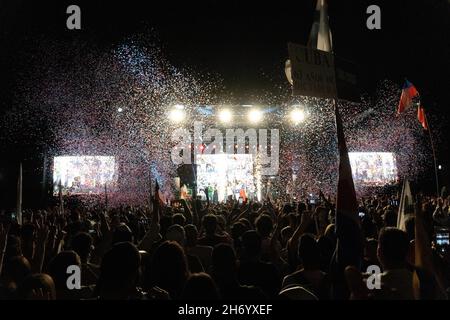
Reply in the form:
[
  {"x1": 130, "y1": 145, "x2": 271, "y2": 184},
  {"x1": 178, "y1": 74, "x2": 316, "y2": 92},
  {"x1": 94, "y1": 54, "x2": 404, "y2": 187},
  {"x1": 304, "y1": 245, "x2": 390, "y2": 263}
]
[{"x1": 0, "y1": 0, "x2": 450, "y2": 205}]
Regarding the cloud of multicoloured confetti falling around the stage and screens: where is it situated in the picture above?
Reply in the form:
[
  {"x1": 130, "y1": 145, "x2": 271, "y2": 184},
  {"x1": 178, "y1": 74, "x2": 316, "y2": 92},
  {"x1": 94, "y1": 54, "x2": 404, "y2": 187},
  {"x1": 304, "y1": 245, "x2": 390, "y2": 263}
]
[{"x1": 4, "y1": 35, "x2": 439, "y2": 203}]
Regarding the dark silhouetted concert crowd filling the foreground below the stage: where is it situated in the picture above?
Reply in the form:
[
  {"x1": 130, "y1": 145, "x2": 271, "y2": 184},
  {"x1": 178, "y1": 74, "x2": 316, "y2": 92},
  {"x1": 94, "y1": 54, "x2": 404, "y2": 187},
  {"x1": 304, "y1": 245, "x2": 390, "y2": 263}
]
[{"x1": 0, "y1": 185, "x2": 450, "y2": 300}]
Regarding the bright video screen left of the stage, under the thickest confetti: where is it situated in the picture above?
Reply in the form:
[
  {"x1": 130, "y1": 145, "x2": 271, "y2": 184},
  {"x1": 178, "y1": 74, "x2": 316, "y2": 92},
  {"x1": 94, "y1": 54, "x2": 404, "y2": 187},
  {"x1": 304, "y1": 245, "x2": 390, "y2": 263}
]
[{"x1": 53, "y1": 156, "x2": 117, "y2": 195}]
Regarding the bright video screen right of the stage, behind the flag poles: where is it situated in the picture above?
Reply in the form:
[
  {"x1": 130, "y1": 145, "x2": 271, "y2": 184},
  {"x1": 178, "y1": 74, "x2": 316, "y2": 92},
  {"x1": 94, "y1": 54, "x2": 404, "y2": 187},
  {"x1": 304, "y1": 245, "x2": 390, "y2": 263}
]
[{"x1": 348, "y1": 152, "x2": 397, "y2": 186}]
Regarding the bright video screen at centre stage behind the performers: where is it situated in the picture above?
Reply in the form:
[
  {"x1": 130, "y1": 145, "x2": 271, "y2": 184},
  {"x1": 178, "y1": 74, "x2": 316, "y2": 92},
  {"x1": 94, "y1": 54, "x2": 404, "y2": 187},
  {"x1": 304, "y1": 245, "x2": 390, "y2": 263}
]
[{"x1": 197, "y1": 154, "x2": 256, "y2": 202}]
